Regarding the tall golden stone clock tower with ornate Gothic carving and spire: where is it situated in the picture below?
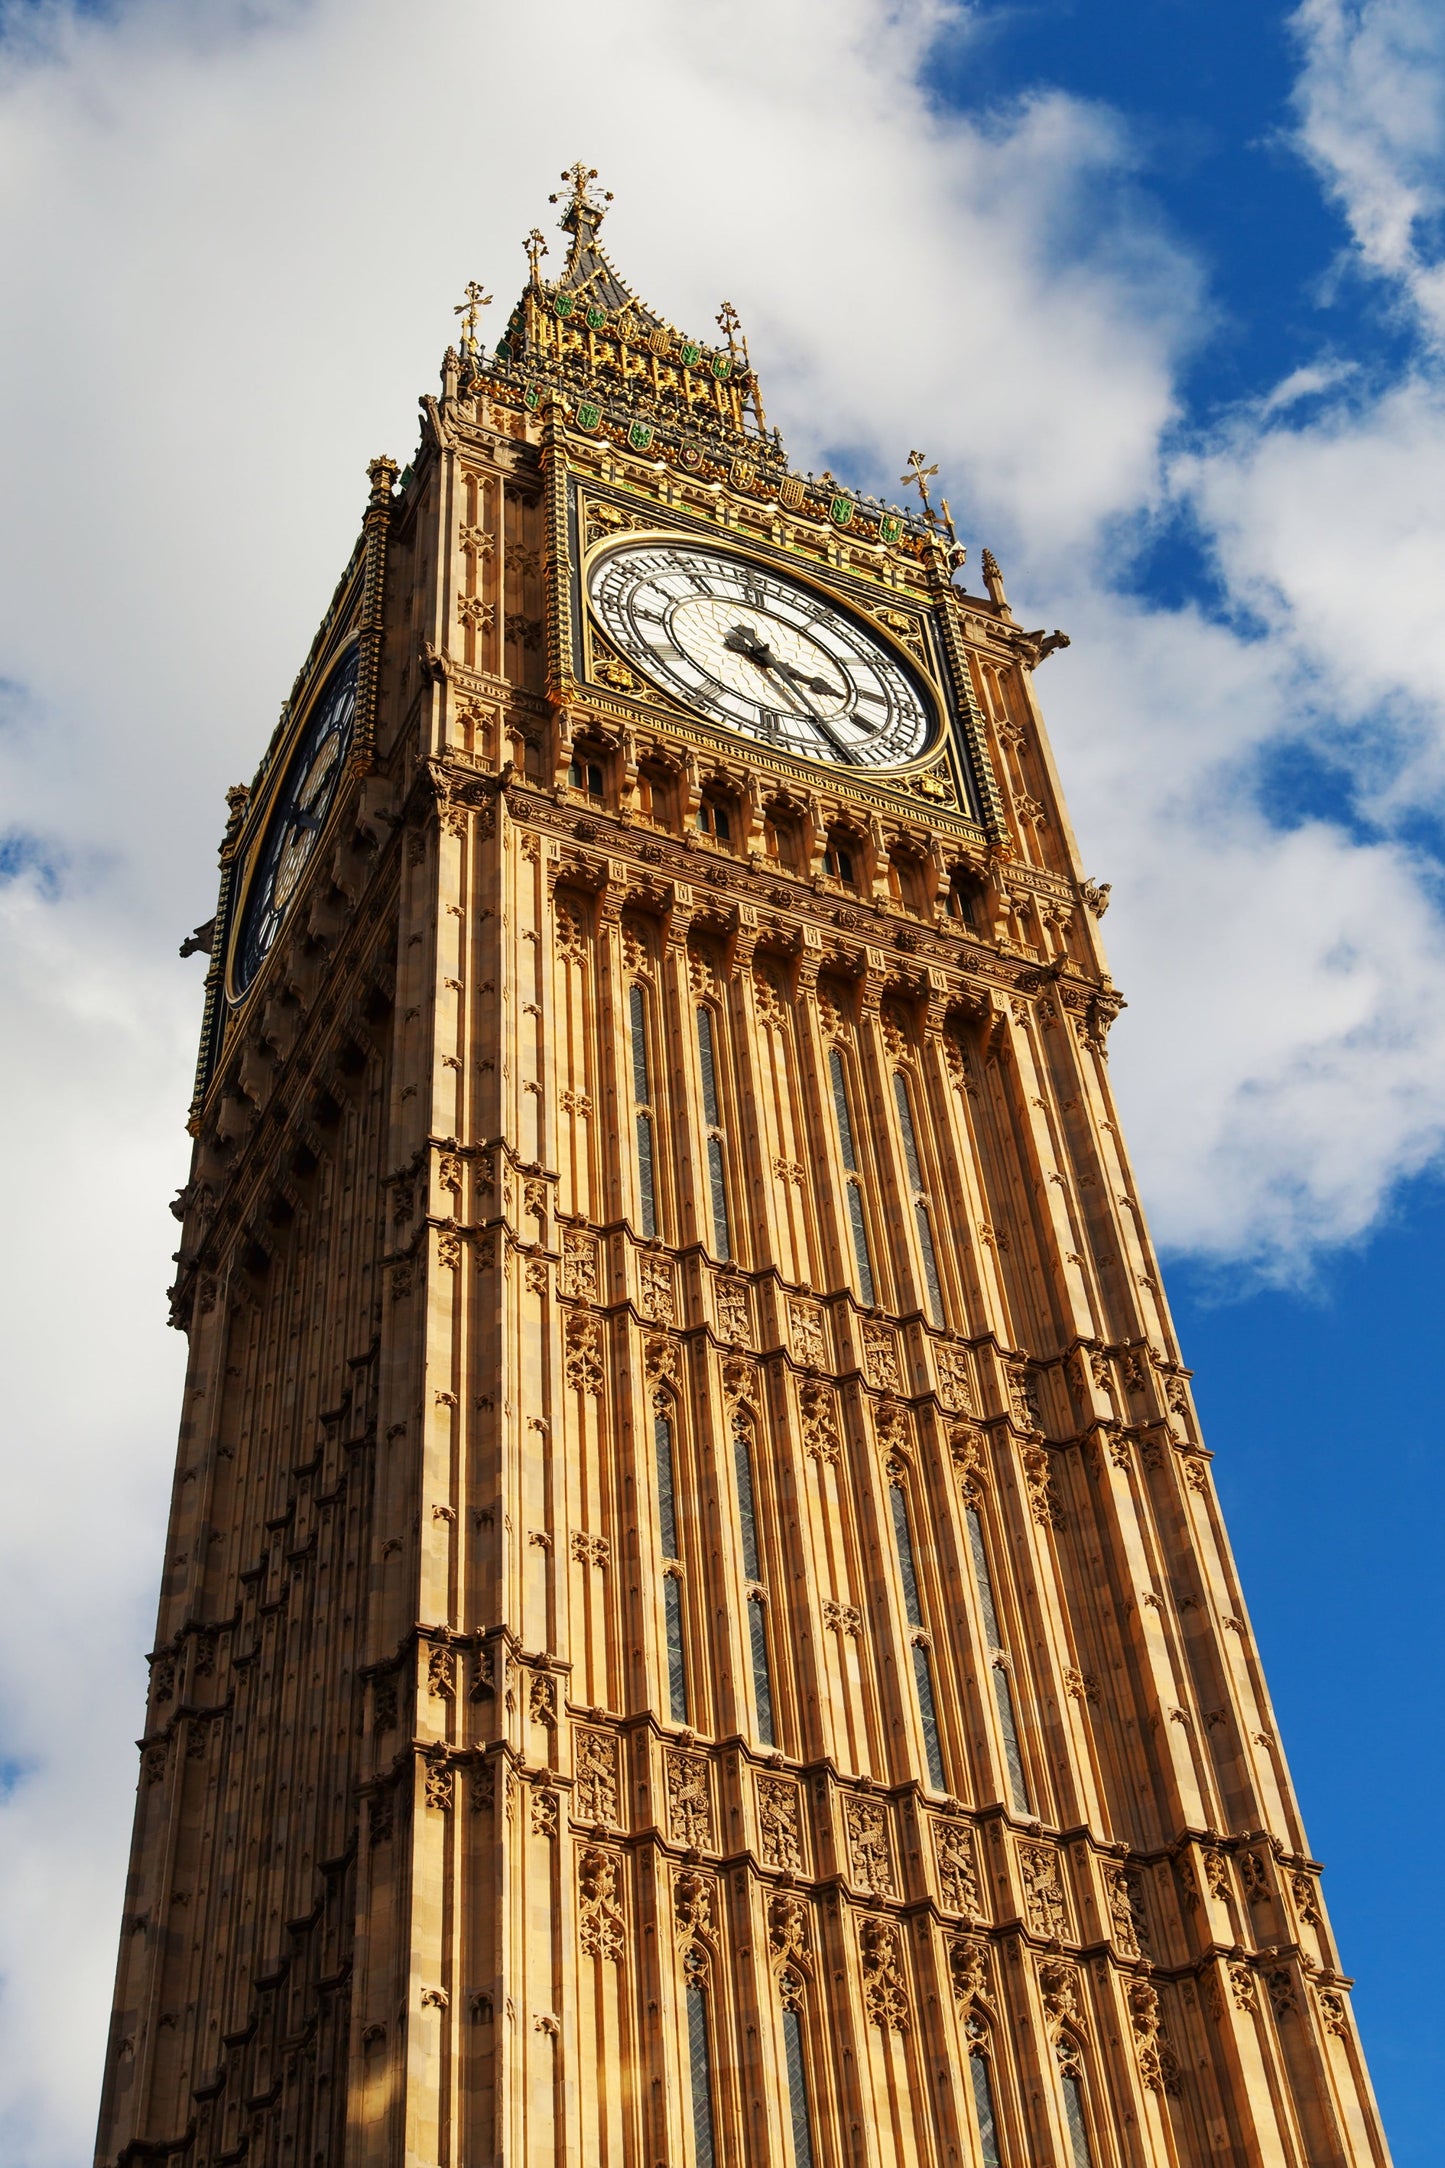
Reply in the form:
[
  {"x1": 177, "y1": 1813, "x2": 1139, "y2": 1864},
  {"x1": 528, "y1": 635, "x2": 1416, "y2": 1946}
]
[{"x1": 100, "y1": 167, "x2": 1387, "y2": 2168}]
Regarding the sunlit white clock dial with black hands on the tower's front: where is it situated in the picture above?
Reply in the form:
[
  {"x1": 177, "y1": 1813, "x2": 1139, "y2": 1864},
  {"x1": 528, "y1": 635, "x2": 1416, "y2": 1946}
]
[{"x1": 587, "y1": 538, "x2": 934, "y2": 767}]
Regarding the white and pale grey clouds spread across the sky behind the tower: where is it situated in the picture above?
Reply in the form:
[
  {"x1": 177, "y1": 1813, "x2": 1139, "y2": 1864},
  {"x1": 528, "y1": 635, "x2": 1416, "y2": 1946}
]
[{"x1": 0, "y1": 0, "x2": 1445, "y2": 2168}]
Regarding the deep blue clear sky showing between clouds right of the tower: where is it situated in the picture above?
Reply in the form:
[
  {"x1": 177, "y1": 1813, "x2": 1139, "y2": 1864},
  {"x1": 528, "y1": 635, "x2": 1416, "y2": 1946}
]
[{"x1": 932, "y1": 0, "x2": 1445, "y2": 2168}]
